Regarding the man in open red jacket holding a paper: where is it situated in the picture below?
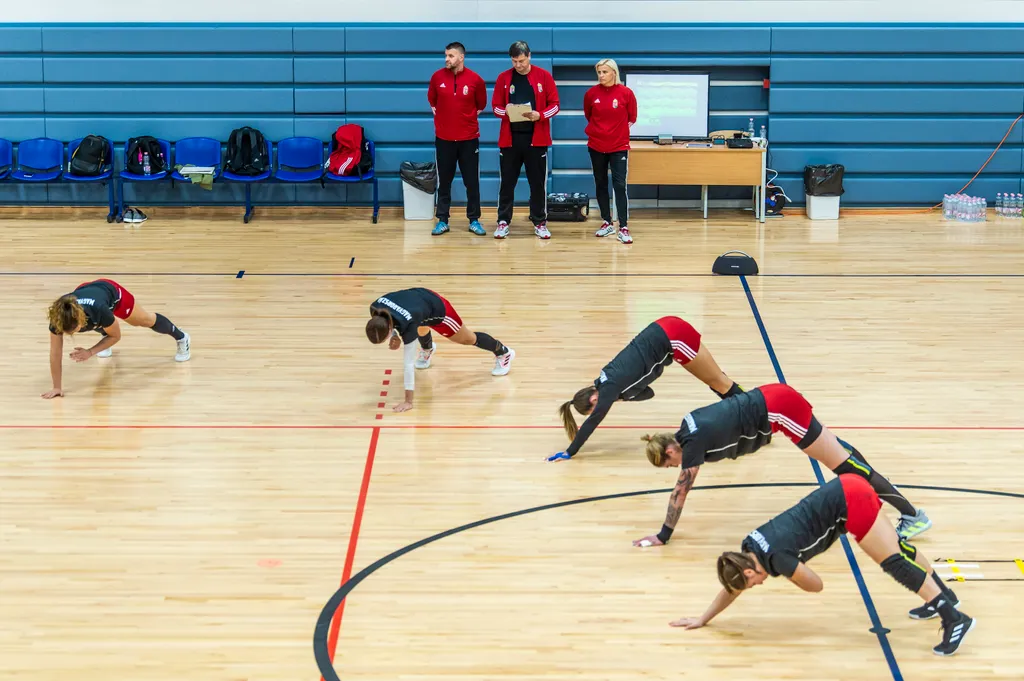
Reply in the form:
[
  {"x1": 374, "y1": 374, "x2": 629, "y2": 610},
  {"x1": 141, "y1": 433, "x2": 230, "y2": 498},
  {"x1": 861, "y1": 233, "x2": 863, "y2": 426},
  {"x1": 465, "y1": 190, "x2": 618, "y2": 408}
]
[{"x1": 490, "y1": 40, "x2": 558, "y2": 239}]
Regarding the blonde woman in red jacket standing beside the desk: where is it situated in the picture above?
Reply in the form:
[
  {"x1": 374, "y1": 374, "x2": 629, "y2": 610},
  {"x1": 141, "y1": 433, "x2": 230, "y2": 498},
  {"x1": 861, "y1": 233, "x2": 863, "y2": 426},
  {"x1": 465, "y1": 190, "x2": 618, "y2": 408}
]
[{"x1": 583, "y1": 59, "x2": 637, "y2": 244}]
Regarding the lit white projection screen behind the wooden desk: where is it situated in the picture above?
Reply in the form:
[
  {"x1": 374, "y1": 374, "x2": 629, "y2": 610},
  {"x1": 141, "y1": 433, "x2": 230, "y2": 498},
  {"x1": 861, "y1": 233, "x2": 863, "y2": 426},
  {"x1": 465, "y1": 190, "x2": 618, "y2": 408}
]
[{"x1": 626, "y1": 74, "x2": 709, "y2": 139}]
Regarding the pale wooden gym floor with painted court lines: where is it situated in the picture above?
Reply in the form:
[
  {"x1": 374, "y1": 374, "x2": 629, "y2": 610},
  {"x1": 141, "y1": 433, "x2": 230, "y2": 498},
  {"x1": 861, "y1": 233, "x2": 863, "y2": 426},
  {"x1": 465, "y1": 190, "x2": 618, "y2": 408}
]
[{"x1": 0, "y1": 209, "x2": 1024, "y2": 681}]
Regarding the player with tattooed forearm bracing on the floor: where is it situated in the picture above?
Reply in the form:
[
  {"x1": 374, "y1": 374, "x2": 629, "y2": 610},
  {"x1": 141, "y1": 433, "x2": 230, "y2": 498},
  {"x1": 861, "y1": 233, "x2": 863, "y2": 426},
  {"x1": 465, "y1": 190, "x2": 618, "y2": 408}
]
[{"x1": 633, "y1": 383, "x2": 932, "y2": 546}]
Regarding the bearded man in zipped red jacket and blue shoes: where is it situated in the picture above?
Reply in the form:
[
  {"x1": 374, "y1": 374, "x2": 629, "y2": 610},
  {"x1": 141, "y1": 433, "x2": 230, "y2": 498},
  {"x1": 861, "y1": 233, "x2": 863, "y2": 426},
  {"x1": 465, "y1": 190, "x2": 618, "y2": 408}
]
[{"x1": 427, "y1": 43, "x2": 487, "y2": 236}]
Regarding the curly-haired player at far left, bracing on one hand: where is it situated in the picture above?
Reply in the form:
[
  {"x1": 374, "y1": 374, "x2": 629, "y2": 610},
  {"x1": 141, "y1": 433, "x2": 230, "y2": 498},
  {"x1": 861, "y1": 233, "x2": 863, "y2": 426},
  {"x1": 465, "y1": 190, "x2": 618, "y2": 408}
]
[{"x1": 43, "y1": 279, "x2": 191, "y2": 399}]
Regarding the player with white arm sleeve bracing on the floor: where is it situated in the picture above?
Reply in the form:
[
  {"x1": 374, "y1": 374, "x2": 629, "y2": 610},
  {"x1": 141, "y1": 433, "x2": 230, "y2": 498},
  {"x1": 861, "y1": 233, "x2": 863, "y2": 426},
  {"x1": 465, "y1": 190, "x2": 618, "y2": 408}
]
[{"x1": 367, "y1": 289, "x2": 515, "y2": 412}]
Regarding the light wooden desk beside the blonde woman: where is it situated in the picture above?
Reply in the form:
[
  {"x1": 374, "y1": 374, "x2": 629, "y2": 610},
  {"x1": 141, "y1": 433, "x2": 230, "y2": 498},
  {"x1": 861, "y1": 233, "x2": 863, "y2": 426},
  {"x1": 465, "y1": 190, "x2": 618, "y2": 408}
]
[{"x1": 626, "y1": 141, "x2": 767, "y2": 222}]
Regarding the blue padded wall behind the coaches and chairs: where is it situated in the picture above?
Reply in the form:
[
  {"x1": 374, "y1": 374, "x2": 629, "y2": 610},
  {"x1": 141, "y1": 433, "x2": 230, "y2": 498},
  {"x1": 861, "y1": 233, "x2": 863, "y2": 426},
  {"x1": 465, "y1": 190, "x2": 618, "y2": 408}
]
[{"x1": 0, "y1": 24, "x2": 1024, "y2": 205}]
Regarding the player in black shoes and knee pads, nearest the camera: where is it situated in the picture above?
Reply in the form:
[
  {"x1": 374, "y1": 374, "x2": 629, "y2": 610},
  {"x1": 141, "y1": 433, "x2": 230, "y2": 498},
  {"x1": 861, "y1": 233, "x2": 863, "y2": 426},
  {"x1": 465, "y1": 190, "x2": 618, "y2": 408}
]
[{"x1": 671, "y1": 474, "x2": 977, "y2": 655}]
